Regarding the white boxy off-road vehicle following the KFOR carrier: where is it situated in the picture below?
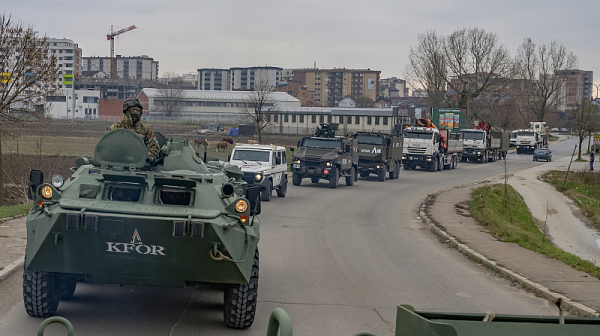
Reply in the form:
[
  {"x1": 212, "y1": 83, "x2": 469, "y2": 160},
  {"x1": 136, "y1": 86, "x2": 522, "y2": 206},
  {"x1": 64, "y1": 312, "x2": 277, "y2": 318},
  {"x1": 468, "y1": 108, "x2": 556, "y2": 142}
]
[{"x1": 229, "y1": 144, "x2": 287, "y2": 201}]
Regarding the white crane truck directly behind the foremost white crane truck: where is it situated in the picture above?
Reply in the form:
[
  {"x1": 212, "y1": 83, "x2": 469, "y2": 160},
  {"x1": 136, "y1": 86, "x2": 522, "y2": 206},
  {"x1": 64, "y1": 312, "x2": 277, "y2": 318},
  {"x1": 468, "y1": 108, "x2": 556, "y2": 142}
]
[{"x1": 461, "y1": 121, "x2": 510, "y2": 163}]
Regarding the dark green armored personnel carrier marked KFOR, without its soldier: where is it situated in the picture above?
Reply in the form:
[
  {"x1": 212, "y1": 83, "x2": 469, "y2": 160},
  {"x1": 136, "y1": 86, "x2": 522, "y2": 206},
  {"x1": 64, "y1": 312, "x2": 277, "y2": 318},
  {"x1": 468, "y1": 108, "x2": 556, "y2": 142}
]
[{"x1": 23, "y1": 129, "x2": 260, "y2": 329}]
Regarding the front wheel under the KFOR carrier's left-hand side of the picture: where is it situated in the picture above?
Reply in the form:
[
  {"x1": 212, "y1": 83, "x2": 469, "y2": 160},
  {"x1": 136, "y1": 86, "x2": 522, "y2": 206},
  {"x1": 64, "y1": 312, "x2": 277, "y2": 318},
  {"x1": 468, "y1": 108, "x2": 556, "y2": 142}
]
[{"x1": 23, "y1": 269, "x2": 59, "y2": 317}]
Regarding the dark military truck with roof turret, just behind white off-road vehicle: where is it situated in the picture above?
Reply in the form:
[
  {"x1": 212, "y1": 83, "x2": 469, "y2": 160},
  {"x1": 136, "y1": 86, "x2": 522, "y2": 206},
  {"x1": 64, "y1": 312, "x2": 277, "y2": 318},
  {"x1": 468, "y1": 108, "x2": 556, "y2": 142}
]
[{"x1": 292, "y1": 124, "x2": 358, "y2": 188}]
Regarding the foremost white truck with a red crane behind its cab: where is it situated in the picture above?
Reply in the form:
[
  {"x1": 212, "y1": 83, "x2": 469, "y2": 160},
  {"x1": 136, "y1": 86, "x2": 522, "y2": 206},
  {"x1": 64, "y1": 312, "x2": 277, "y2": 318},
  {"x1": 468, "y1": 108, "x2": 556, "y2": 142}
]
[{"x1": 402, "y1": 119, "x2": 463, "y2": 172}]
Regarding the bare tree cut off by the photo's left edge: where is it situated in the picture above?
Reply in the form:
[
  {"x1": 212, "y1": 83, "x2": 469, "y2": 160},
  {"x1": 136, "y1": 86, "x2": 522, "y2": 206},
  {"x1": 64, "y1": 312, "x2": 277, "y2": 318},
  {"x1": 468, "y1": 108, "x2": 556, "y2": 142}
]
[{"x1": 0, "y1": 14, "x2": 62, "y2": 204}]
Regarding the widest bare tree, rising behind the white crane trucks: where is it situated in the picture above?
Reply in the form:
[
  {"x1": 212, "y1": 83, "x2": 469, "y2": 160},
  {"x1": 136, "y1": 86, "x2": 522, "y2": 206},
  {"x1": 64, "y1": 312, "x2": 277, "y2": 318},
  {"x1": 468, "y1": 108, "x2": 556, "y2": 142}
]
[{"x1": 406, "y1": 28, "x2": 512, "y2": 122}]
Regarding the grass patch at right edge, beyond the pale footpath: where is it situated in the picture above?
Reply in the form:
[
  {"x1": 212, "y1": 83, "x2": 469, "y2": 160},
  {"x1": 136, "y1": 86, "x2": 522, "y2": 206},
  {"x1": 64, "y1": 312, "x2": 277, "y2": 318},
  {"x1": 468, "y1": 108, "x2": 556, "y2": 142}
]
[{"x1": 542, "y1": 170, "x2": 600, "y2": 230}]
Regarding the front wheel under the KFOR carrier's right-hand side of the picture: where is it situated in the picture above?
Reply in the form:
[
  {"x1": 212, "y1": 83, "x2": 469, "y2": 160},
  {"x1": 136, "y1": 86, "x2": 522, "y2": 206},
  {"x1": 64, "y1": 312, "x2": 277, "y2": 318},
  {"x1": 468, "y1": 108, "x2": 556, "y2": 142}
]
[{"x1": 223, "y1": 247, "x2": 258, "y2": 329}]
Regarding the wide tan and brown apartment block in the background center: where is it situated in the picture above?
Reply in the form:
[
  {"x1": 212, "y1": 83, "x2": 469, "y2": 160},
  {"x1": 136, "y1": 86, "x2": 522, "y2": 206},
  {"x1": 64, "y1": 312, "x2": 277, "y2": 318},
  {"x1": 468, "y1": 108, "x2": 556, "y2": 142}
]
[{"x1": 294, "y1": 68, "x2": 381, "y2": 107}]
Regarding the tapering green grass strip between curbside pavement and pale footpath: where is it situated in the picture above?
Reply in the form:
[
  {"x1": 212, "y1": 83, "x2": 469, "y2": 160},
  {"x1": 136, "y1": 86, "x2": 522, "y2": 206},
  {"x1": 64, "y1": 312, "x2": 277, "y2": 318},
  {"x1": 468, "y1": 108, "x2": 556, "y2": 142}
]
[{"x1": 469, "y1": 184, "x2": 600, "y2": 278}]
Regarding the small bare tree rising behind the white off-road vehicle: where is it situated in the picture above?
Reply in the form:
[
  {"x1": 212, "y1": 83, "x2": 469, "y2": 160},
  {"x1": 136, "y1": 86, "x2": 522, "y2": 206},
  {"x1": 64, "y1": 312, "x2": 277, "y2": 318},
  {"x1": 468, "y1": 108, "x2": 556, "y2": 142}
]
[{"x1": 240, "y1": 81, "x2": 277, "y2": 144}]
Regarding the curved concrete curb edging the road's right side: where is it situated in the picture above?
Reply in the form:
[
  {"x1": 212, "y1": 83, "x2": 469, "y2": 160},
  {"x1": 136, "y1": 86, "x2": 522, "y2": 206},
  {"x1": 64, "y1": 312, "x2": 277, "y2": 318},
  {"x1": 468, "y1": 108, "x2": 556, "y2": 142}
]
[{"x1": 419, "y1": 180, "x2": 600, "y2": 317}]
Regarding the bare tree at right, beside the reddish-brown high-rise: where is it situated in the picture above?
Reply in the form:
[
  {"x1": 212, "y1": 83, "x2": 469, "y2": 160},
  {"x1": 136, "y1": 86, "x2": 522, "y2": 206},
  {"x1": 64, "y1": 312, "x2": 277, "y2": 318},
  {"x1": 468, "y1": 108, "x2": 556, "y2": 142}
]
[{"x1": 515, "y1": 38, "x2": 578, "y2": 122}]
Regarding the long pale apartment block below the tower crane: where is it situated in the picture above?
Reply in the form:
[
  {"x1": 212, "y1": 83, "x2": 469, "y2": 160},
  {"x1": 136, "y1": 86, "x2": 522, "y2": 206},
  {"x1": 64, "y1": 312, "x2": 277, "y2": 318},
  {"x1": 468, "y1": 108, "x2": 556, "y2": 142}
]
[{"x1": 83, "y1": 55, "x2": 158, "y2": 80}]
